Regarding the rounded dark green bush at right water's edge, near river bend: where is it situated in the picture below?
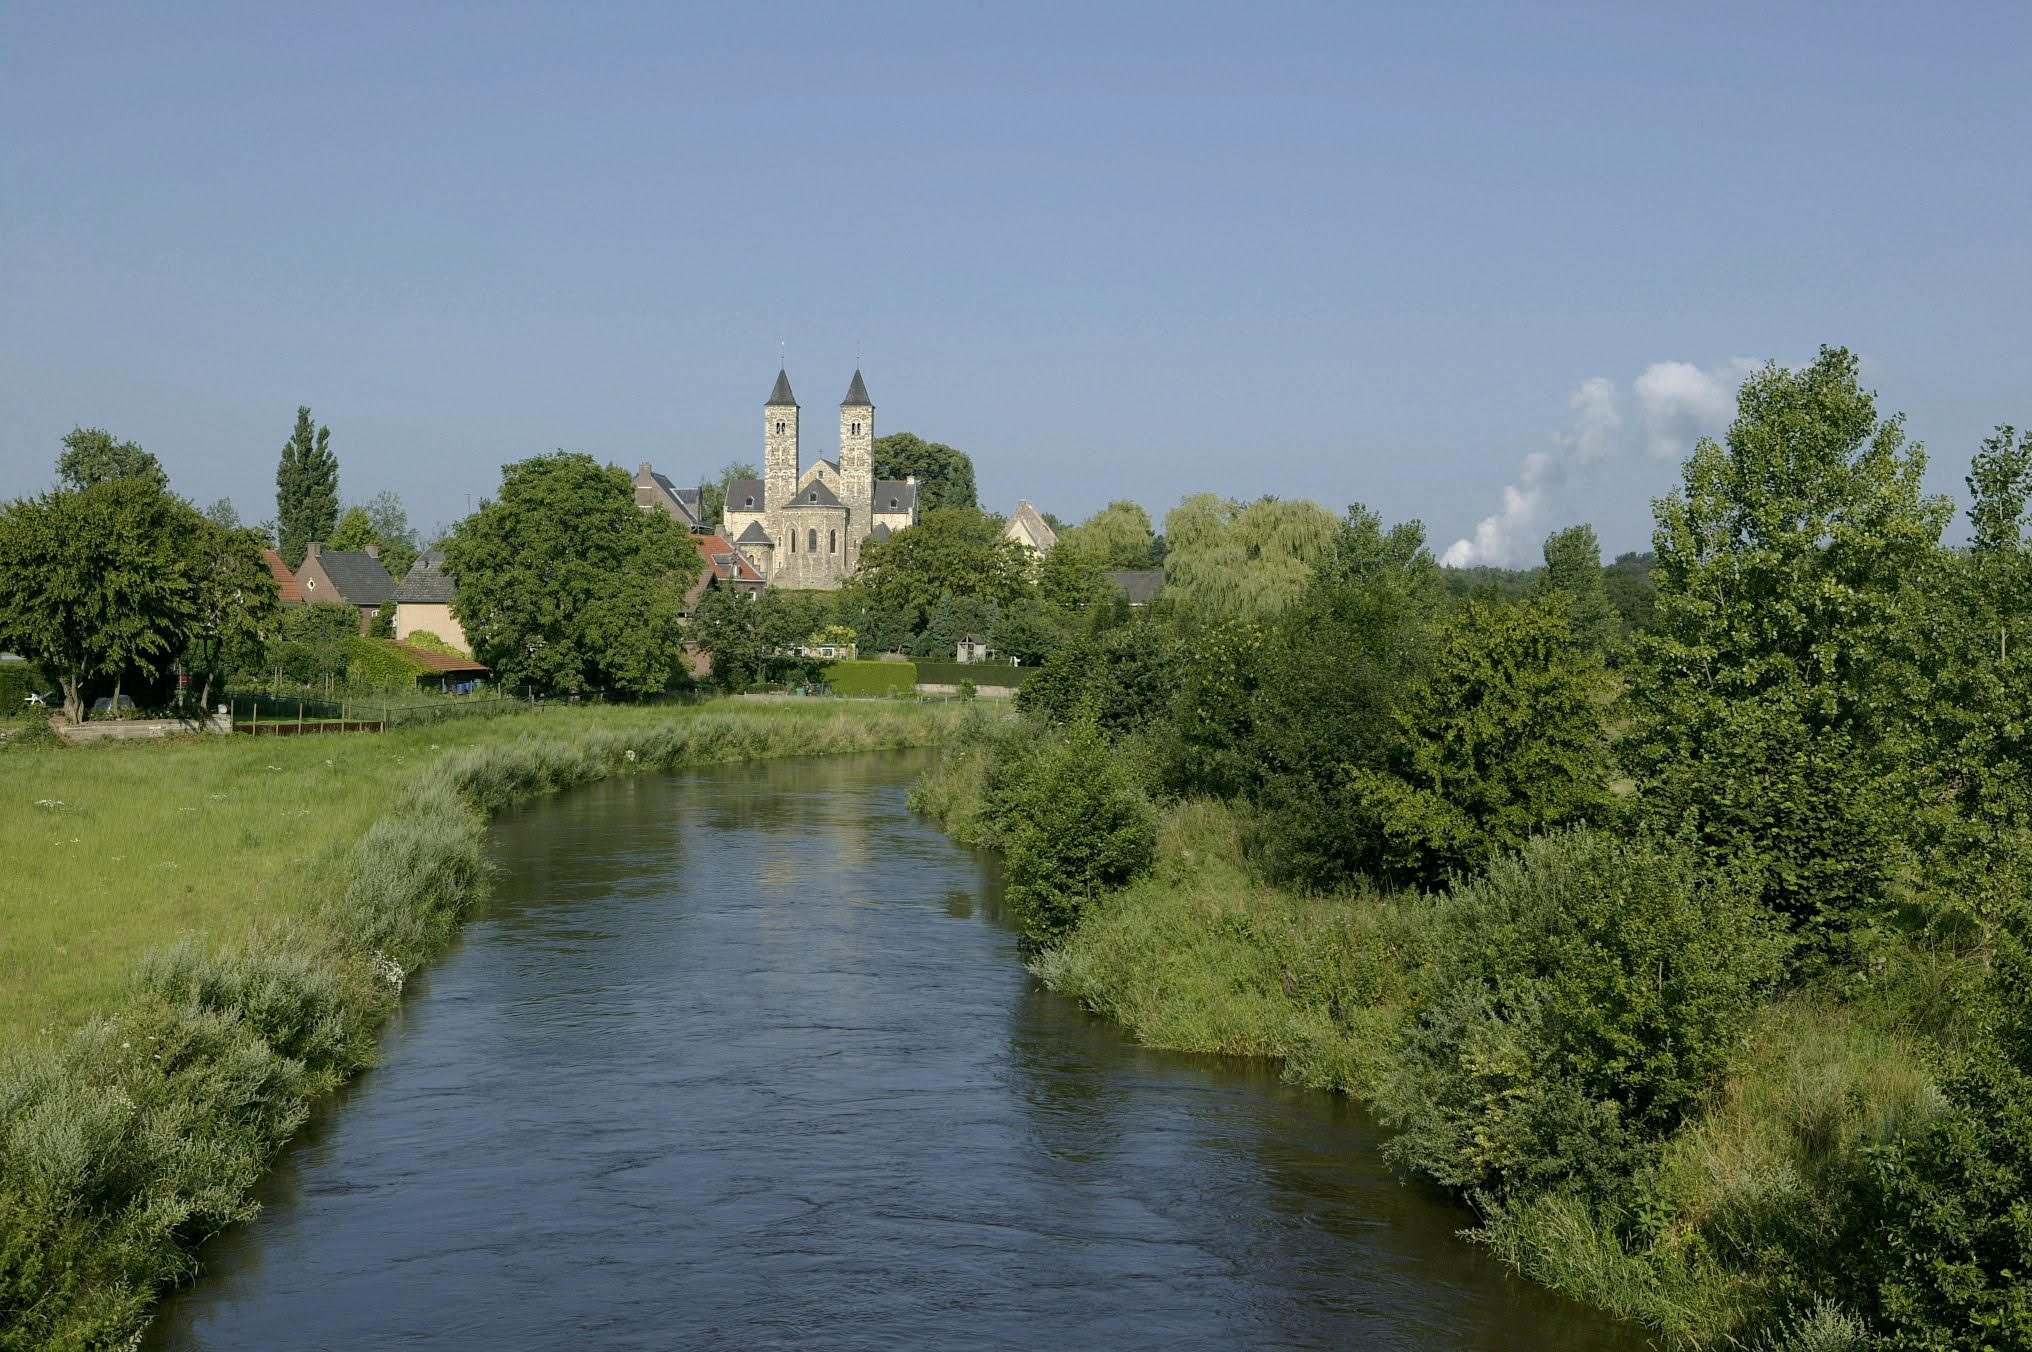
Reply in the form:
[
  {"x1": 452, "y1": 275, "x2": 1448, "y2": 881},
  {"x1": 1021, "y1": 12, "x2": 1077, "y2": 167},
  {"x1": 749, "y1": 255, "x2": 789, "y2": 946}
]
[{"x1": 1004, "y1": 722, "x2": 1156, "y2": 943}]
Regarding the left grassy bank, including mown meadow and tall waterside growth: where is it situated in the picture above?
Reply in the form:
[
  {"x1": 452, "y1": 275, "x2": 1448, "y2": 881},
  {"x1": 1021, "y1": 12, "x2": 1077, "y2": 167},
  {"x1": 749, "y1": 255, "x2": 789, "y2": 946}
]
[{"x1": 0, "y1": 703, "x2": 975, "y2": 1348}]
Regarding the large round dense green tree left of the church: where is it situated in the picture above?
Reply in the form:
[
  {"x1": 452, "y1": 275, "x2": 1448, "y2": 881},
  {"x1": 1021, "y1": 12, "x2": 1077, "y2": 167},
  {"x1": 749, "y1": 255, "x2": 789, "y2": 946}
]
[{"x1": 445, "y1": 451, "x2": 697, "y2": 693}]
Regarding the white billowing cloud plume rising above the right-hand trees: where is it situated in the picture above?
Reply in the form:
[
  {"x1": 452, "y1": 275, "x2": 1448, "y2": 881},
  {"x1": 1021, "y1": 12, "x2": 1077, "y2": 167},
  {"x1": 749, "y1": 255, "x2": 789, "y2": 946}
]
[{"x1": 1439, "y1": 358, "x2": 1758, "y2": 567}]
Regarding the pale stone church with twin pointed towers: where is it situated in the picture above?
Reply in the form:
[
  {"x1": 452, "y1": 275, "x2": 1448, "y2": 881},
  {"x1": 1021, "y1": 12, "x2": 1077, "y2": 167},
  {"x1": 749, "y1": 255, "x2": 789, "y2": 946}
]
[{"x1": 719, "y1": 370, "x2": 916, "y2": 590}]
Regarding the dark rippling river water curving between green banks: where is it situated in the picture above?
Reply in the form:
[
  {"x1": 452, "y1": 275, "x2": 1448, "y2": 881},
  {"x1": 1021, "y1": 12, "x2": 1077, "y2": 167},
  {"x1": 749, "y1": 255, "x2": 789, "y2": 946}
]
[{"x1": 148, "y1": 754, "x2": 1644, "y2": 1352}]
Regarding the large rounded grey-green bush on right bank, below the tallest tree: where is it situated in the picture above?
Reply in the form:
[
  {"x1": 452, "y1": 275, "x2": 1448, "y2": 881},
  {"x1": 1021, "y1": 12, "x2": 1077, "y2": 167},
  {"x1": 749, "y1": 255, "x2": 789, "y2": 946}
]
[{"x1": 1382, "y1": 832, "x2": 1784, "y2": 1197}]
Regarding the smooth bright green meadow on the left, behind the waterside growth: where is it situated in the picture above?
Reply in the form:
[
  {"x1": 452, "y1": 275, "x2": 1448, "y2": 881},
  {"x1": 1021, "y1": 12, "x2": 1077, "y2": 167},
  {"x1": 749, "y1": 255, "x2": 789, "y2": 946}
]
[{"x1": 0, "y1": 701, "x2": 934, "y2": 1047}]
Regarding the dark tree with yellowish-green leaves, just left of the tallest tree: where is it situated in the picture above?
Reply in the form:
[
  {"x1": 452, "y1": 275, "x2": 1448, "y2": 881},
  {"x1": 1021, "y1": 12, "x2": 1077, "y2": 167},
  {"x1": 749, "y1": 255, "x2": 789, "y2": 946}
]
[{"x1": 1349, "y1": 597, "x2": 1613, "y2": 886}]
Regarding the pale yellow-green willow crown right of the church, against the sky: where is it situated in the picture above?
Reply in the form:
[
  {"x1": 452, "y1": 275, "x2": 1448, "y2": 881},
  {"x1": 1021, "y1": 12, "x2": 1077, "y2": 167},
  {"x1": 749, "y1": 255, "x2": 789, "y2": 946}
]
[{"x1": 1170, "y1": 492, "x2": 1335, "y2": 620}]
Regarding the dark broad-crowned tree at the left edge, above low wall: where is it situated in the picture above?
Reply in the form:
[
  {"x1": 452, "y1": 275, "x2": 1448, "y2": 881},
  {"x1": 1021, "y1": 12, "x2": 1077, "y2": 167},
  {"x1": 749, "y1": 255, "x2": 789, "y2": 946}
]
[{"x1": 0, "y1": 474, "x2": 199, "y2": 722}]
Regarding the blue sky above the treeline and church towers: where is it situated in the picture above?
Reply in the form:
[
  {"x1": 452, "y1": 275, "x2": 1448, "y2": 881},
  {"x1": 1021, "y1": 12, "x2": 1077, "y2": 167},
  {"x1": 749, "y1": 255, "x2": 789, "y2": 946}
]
[{"x1": 0, "y1": 0, "x2": 2032, "y2": 561}]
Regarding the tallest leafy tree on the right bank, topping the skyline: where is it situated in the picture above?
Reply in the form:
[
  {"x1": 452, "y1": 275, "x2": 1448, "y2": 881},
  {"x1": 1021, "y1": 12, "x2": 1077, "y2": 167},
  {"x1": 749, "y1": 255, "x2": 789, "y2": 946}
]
[{"x1": 1626, "y1": 348, "x2": 1949, "y2": 939}]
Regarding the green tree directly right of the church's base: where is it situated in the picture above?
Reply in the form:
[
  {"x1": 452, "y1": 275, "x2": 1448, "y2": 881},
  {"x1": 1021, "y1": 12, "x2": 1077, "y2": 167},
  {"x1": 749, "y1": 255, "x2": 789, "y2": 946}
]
[{"x1": 843, "y1": 506, "x2": 1028, "y2": 634}]
